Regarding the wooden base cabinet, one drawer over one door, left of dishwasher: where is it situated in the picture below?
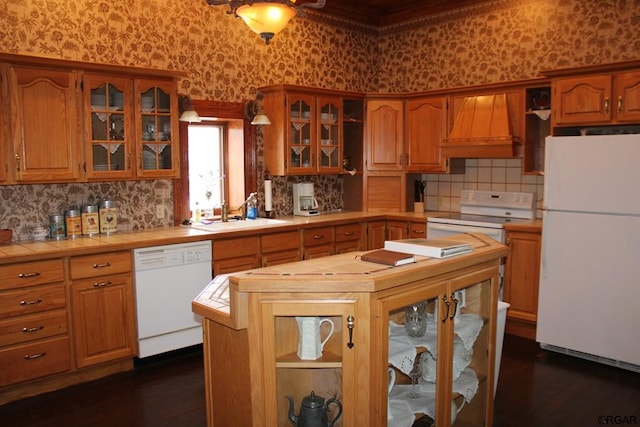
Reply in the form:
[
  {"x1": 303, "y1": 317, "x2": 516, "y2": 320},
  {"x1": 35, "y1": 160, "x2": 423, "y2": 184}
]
[{"x1": 70, "y1": 251, "x2": 137, "y2": 368}]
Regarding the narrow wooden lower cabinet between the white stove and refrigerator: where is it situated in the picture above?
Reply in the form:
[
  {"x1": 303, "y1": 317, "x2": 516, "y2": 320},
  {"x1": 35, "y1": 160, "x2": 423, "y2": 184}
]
[{"x1": 504, "y1": 230, "x2": 542, "y2": 339}]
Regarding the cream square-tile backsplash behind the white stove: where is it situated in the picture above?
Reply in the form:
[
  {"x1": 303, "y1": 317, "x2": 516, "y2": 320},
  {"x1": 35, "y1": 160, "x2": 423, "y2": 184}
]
[{"x1": 425, "y1": 159, "x2": 544, "y2": 218}]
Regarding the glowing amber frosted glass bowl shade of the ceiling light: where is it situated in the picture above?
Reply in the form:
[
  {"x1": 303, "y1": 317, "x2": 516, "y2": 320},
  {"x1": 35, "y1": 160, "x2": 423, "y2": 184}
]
[{"x1": 236, "y1": 2, "x2": 296, "y2": 38}]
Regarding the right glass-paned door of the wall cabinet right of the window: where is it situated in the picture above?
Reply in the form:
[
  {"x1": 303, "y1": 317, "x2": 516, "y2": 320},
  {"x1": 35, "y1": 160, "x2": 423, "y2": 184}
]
[{"x1": 317, "y1": 97, "x2": 342, "y2": 173}]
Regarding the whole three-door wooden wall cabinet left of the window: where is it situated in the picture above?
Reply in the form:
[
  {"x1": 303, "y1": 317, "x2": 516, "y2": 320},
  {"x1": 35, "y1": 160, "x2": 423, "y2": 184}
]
[{"x1": 0, "y1": 53, "x2": 182, "y2": 184}]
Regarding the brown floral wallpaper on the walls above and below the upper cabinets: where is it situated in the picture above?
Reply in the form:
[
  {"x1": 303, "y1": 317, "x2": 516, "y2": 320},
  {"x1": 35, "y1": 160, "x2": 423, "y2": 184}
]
[{"x1": 0, "y1": 0, "x2": 640, "y2": 238}]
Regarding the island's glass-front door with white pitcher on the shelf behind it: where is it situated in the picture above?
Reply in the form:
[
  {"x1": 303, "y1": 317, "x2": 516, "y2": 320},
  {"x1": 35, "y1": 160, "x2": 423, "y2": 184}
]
[{"x1": 249, "y1": 297, "x2": 360, "y2": 427}]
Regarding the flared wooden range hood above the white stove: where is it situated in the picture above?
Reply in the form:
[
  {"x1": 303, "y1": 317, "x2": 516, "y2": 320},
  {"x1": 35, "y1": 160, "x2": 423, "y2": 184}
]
[{"x1": 440, "y1": 93, "x2": 520, "y2": 158}]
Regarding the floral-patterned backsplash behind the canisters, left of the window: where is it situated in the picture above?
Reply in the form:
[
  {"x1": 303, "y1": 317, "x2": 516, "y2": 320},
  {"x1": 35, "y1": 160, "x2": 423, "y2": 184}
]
[{"x1": 0, "y1": 180, "x2": 173, "y2": 241}]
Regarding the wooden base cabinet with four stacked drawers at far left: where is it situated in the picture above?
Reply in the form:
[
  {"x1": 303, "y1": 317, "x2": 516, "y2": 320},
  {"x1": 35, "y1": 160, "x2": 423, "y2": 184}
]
[{"x1": 0, "y1": 259, "x2": 72, "y2": 388}]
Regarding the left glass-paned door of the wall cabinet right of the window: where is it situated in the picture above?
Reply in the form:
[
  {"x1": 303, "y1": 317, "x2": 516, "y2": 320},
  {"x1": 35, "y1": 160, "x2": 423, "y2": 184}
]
[{"x1": 286, "y1": 94, "x2": 316, "y2": 174}]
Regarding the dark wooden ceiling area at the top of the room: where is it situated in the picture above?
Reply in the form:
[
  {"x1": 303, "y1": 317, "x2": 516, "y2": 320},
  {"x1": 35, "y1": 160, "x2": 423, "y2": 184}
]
[{"x1": 304, "y1": 0, "x2": 489, "y2": 27}]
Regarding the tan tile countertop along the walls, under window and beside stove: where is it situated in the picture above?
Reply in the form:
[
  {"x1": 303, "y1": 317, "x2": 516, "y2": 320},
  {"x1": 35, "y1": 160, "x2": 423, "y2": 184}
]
[{"x1": 0, "y1": 211, "x2": 541, "y2": 265}]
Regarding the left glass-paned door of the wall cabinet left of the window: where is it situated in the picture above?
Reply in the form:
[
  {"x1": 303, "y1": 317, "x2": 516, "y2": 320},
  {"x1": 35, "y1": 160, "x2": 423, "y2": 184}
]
[{"x1": 83, "y1": 74, "x2": 134, "y2": 179}]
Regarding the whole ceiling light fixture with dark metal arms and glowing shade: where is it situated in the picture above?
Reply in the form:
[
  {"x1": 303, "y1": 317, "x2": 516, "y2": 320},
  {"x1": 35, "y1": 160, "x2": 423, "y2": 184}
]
[{"x1": 207, "y1": 0, "x2": 326, "y2": 44}]
